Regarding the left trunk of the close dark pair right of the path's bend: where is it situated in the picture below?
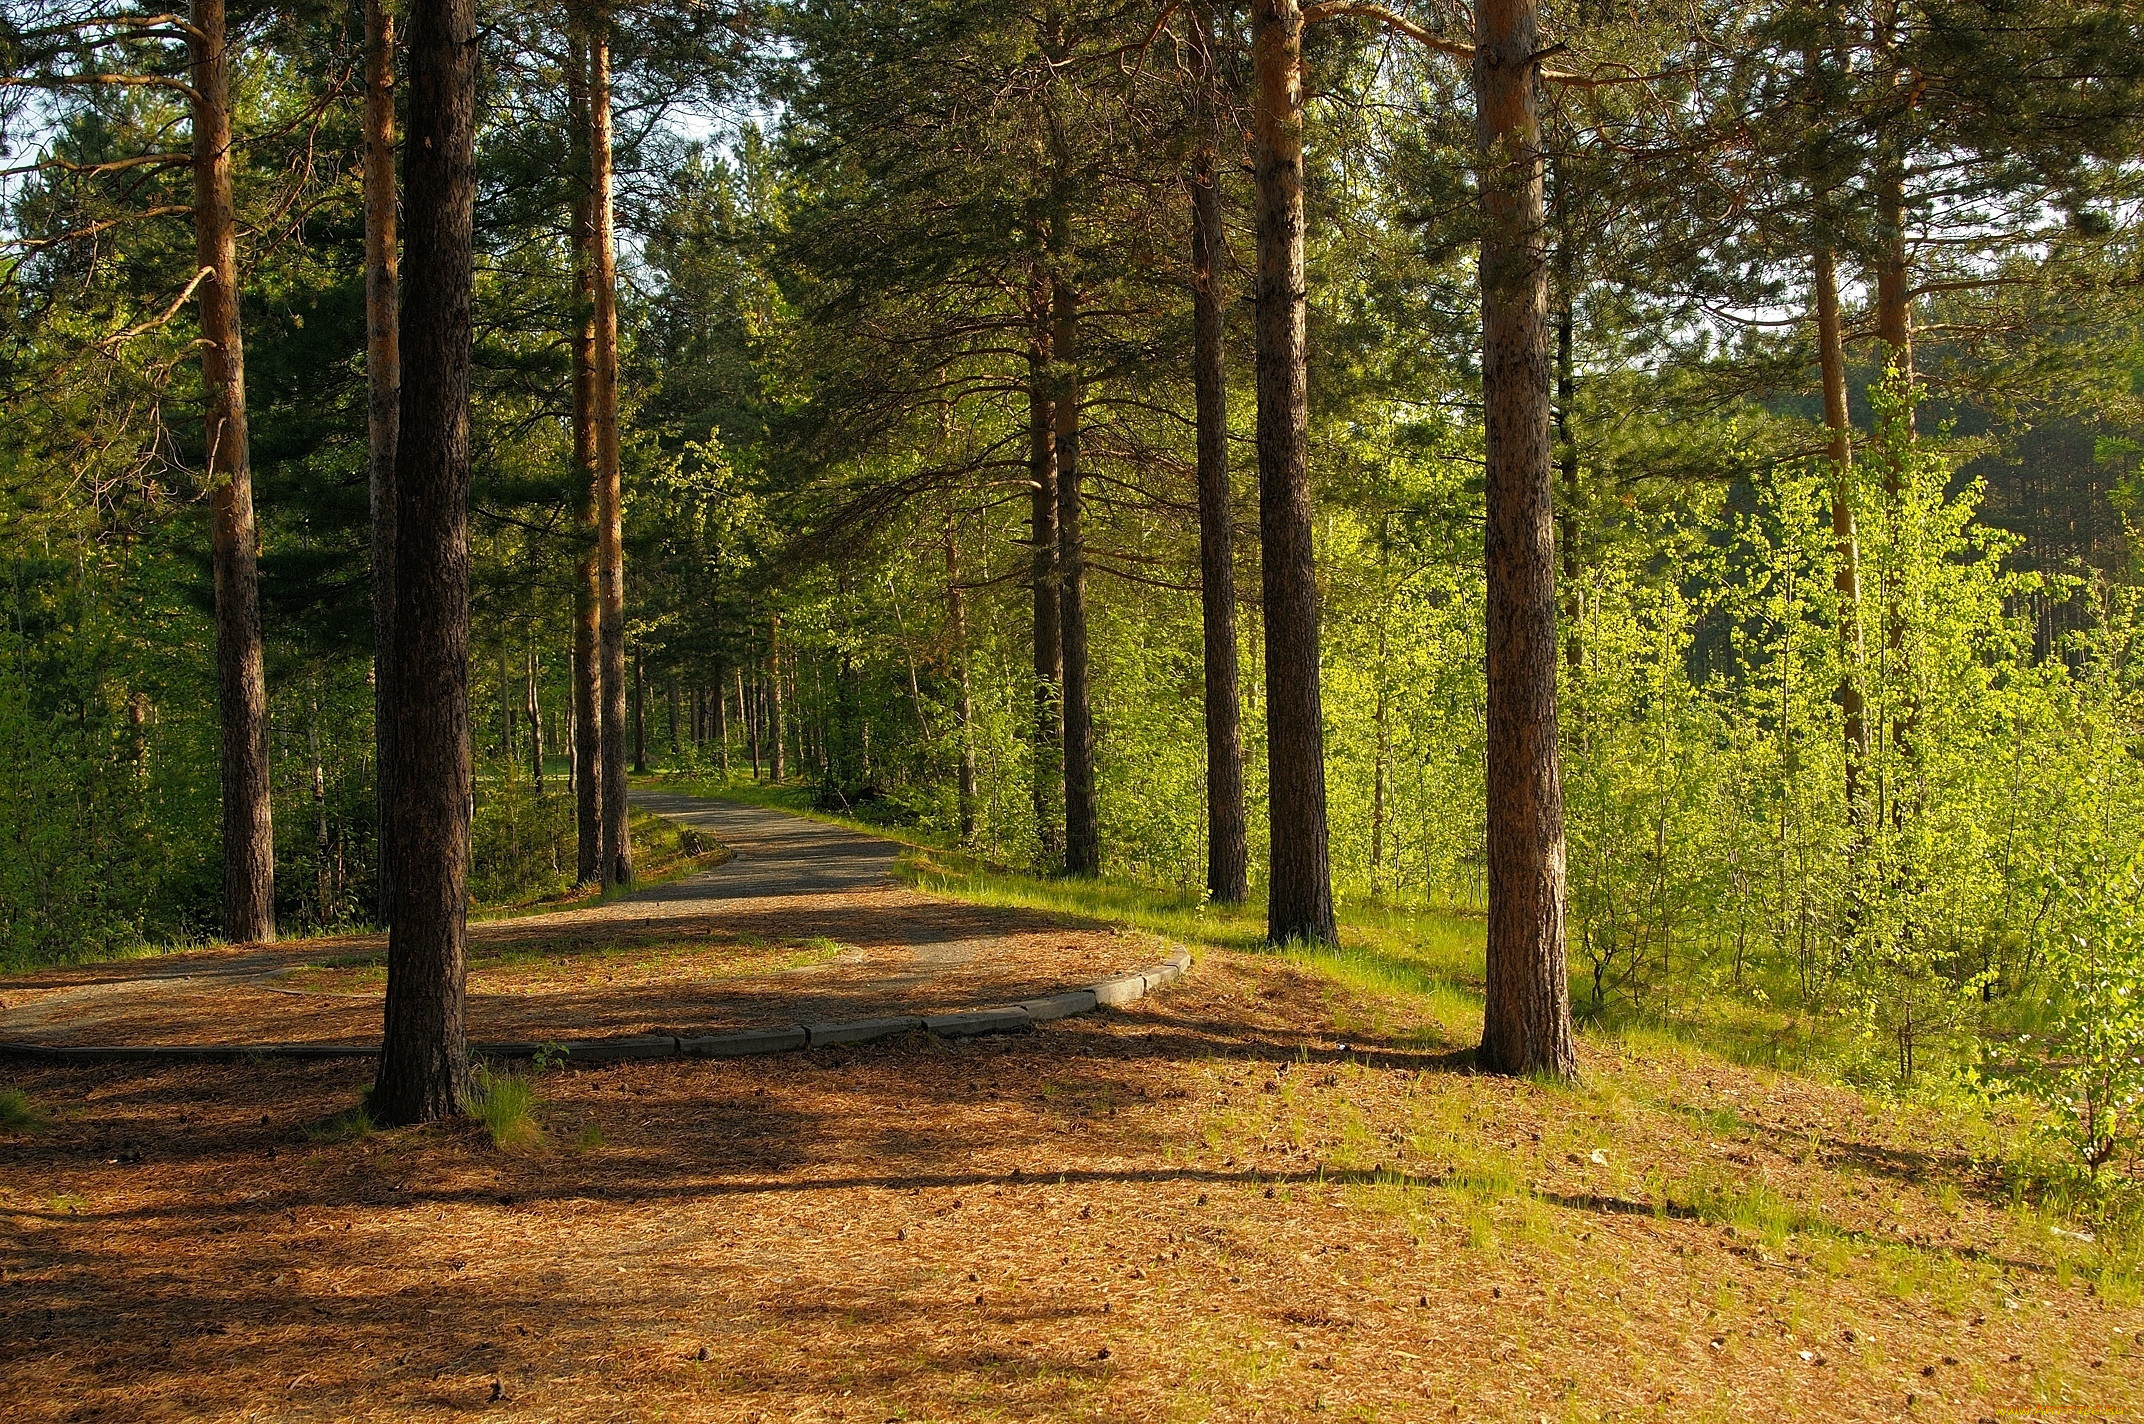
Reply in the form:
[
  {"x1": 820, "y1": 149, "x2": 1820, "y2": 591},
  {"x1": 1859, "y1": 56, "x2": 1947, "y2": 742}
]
[{"x1": 1027, "y1": 264, "x2": 1063, "y2": 871}]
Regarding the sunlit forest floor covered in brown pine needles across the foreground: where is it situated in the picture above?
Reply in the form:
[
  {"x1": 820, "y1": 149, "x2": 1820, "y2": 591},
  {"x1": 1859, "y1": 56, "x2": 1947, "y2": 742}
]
[{"x1": 0, "y1": 793, "x2": 2144, "y2": 1424}]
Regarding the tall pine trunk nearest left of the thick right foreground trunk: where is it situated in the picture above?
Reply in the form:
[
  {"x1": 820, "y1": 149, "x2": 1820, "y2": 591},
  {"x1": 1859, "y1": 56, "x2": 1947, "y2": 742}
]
[{"x1": 1252, "y1": 0, "x2": 1338, "y2": 944}]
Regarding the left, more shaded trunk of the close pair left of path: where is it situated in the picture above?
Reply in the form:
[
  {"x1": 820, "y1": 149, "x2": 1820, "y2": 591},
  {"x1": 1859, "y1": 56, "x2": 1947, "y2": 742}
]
[{"x1": 566, "y1": 26, "x2": 602, "y2": 886}]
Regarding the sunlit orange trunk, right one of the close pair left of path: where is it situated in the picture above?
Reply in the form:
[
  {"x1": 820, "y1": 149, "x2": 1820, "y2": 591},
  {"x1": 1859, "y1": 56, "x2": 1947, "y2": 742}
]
[{"x1": 587, "y1": 4, "x2": 632, "y2": 886}]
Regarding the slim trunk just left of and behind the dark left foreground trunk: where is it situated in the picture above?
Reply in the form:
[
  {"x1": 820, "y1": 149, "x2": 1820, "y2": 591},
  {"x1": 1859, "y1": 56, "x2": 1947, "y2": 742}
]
[{"x1": 364, "y1": 0, "x2": 401, "y2": 924}]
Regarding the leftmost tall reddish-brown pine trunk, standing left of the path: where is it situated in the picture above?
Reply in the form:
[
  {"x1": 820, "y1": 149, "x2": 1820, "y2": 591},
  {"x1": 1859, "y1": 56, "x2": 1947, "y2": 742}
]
[{"x1": 189, "y1": 0, "x2": 274, "y2": 941}]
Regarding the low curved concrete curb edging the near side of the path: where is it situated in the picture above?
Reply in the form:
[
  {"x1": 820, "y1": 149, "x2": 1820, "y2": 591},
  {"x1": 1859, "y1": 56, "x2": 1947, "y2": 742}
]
[{"x1": 0, "y1": 948, "x2": 1192, "y2": 1064}]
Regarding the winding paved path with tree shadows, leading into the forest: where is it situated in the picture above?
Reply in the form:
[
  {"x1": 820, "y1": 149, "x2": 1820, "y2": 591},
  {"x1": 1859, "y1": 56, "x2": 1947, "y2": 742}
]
[{"x1": 0, "y1": 791, "x2": 1156, "y2": 1044}]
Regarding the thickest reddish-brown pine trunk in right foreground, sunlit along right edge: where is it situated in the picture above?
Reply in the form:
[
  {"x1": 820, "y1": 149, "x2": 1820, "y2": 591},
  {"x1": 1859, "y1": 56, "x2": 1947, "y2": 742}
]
[{"x1": 1475, "y1": 0, "x2": 1578, "y2": 1079}]
